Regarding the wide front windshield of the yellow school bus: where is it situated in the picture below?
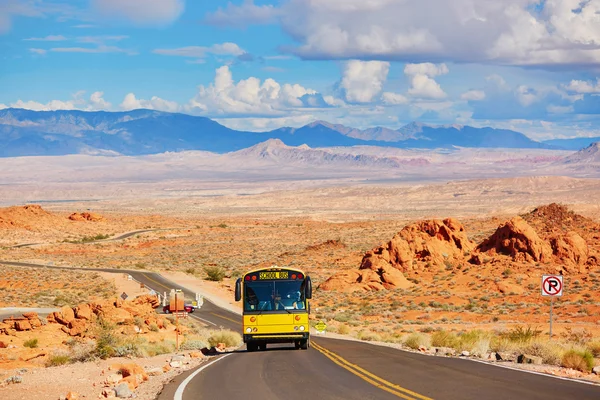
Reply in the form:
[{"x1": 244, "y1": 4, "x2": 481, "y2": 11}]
[{"x1": 244, "y1": 281, "x2": 306, "y2": 311}]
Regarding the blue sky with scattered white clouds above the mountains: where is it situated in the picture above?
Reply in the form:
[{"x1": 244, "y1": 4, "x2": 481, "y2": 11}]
[{"x1": 0, "y1": 0, "x2": 600, "y2": 139}]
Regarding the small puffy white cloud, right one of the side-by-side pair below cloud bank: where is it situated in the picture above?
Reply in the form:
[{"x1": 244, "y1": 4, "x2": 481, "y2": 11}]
[{"x1": 404, "y1": 63, "x2": 448, "y2": 100}]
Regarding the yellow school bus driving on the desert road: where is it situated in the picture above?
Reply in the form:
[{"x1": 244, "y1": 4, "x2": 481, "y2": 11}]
[{"x1": 235, "y1": 267, "x2": 312, "y2": 351}]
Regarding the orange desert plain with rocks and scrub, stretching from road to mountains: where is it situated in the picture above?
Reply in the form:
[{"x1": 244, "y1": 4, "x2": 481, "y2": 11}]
[{"x1": 0, "y1": 143, "x2": 600, "y2": 396}]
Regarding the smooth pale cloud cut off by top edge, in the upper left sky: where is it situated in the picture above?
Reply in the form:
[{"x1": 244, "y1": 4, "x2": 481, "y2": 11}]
[{"x1": 92, "y1": 0, "x2": 185, "y2": 25}]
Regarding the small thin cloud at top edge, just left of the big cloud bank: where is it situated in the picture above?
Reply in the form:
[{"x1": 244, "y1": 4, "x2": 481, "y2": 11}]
[{"x1": 205, "y1": 0, "x2": 280, "y2": 27}]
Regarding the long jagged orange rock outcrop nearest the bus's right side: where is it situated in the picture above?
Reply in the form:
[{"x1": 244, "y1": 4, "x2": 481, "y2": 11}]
[{"x1": 319, "y1": 218, "x2": 475, "y2": 292}]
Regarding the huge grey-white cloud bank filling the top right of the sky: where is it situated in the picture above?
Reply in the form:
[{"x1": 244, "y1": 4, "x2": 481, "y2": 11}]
[{"x1": 219, "y1": 0, "x2": 600, "y2": 66}]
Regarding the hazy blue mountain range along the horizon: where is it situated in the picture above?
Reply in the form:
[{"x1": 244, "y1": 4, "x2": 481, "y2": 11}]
[{"x1": 0, "y1": 108, "x2": 584, "y2": 158}]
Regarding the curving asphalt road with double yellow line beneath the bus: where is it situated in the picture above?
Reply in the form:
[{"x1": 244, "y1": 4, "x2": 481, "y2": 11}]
[{"x1": 0, "y1": 261, "x2": 600, "y2": 400}]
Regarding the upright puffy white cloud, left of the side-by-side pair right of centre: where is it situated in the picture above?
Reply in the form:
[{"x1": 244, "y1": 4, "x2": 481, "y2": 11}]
[{"x1": 340, "y1": 60, "x2": 390, "y2": 103}]
